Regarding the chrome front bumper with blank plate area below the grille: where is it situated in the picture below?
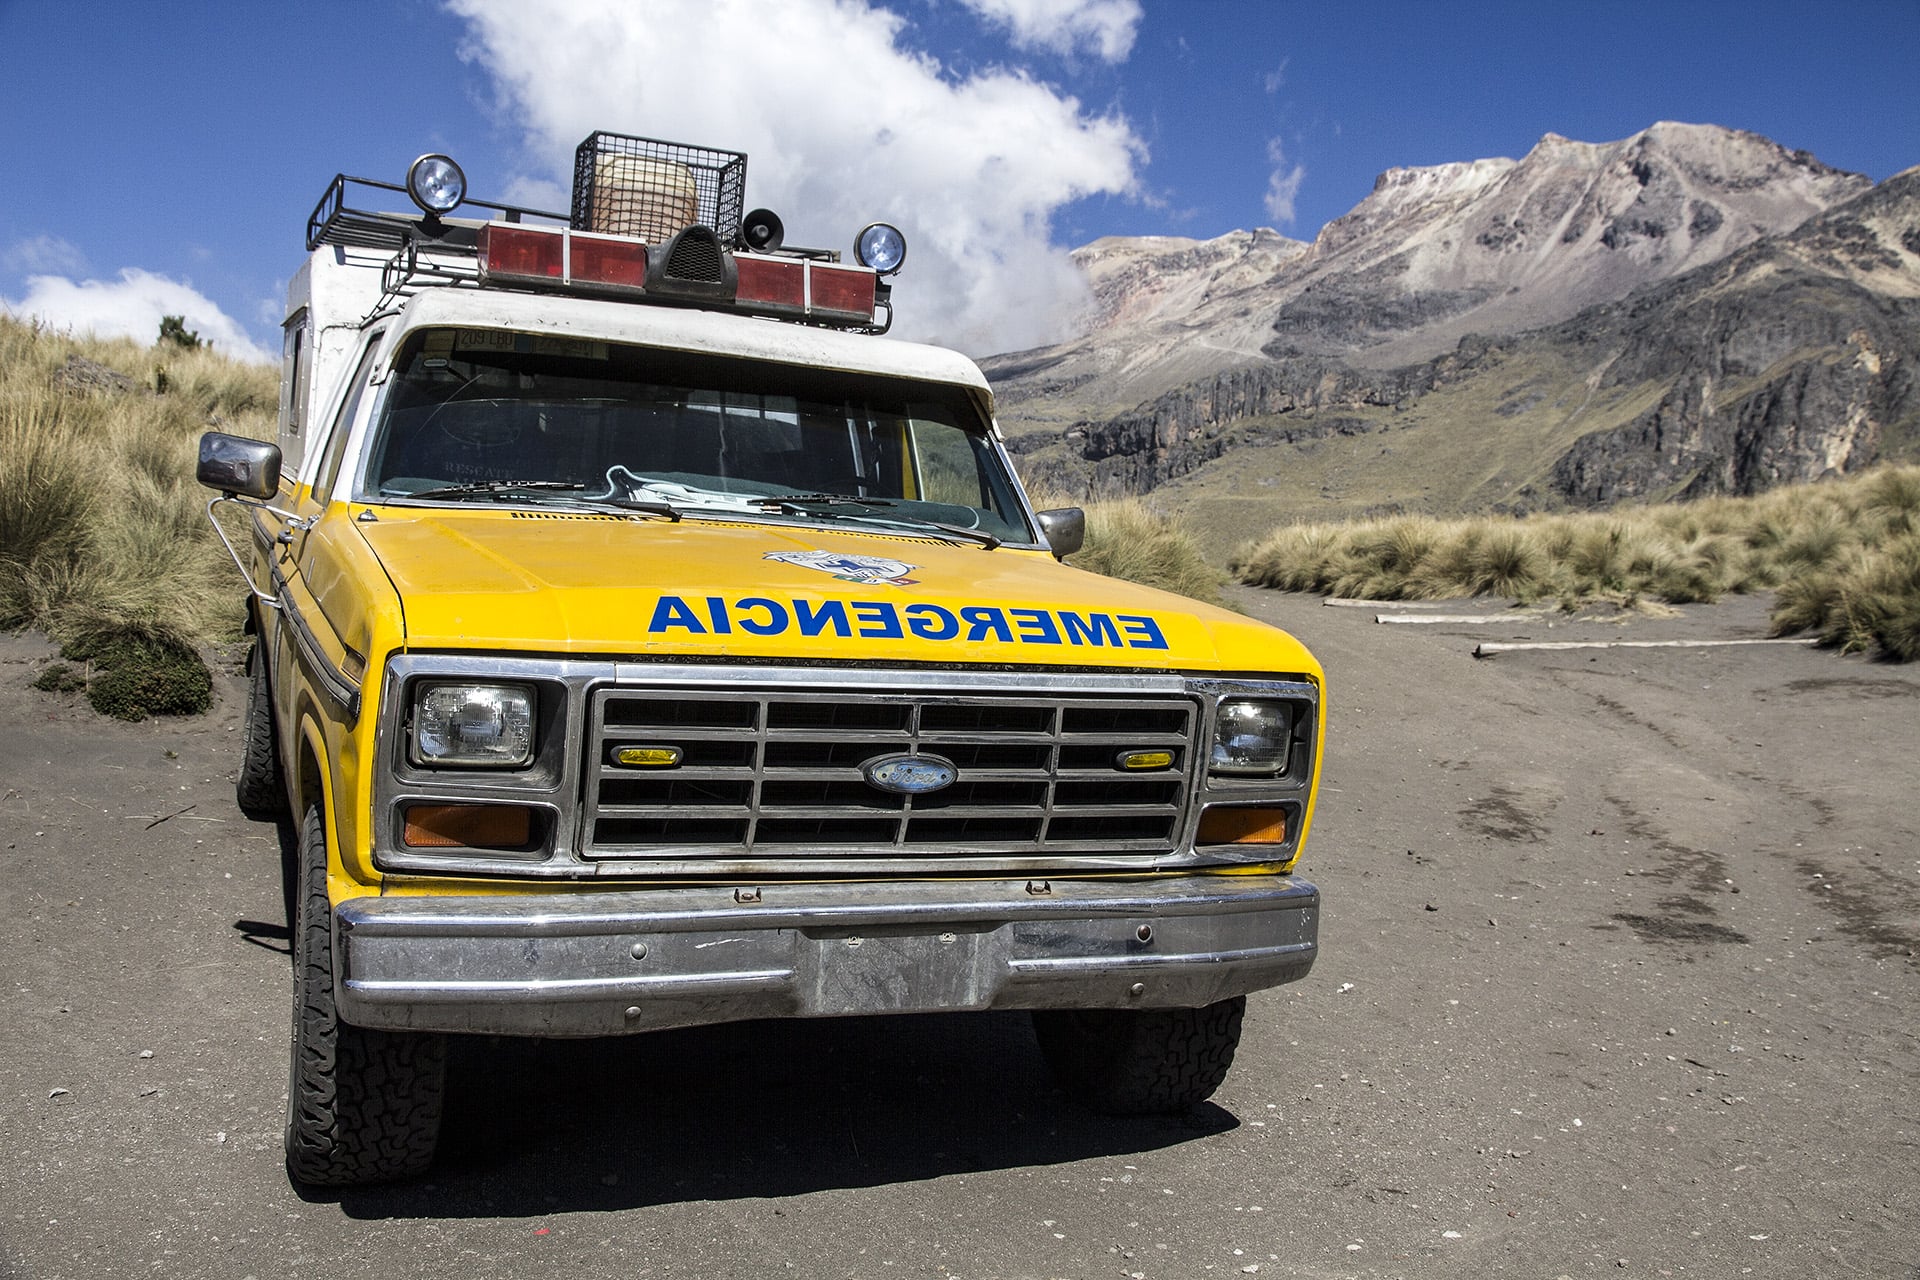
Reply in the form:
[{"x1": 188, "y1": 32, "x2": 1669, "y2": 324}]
[{"x1": 334, "y1": 875, "x2": 1319, "y2": 1036}]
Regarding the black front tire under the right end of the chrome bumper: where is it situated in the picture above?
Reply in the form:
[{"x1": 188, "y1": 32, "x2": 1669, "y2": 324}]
[{"x1": 1033, "y1": 996, "x2": 1246, "y2": 1115}]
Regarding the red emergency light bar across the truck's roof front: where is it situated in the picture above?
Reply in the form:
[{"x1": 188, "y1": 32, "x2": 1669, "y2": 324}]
[{"x1": 478, "y1": 223, "x2": 879, "y2": 328}]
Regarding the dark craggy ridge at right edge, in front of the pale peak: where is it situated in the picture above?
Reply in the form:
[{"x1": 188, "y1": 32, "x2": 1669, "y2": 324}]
[{"x1": 1551, "y1": 169, "x2": 1920, "y2": 505}]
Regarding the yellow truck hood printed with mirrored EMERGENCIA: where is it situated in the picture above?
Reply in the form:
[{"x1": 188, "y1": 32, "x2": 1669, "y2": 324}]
[{"x1": 353, "y1": 507, "x2": 1319, "y2": 677}]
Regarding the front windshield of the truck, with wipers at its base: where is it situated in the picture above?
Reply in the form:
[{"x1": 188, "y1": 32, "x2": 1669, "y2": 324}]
[{"x1": 363, "y1": 328, "x2": 1035, "y2": 543}]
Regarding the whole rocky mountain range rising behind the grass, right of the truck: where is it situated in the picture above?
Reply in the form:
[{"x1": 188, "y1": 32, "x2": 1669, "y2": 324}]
[{"x1": 987, "y1": 125, "x2": 1920, "y2": 541}]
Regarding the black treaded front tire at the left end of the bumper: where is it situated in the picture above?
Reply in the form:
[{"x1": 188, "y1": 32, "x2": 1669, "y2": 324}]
[{"x1": 286, "y1": 806, "x2": 447, "y2": 1186}]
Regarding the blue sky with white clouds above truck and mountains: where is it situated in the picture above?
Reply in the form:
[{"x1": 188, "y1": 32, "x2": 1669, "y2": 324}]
[{"x1": 0, "y1": 0, "x2": 1920, "y2": 353}]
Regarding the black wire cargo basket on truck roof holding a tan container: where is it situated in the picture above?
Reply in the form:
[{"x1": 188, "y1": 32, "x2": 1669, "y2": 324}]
[{"x1": 572, "y1": 132, "x2": 747, "y2": 244}]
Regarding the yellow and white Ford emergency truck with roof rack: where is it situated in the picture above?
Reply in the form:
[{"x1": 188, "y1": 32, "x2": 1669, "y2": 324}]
[{"x1": 198, "y1": 134, "x2": 1325, "y2": 1186}]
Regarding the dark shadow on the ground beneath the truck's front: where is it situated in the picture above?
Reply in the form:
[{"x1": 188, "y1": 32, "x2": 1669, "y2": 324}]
[{"x1": 314, "y1": 1013, "x2": 1238, "y2": 1219}]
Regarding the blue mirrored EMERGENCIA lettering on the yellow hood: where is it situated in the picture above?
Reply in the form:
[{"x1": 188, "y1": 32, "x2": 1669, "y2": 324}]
[{"x1": 647, "y1": 595, "x2": 1167, "y2": 649}]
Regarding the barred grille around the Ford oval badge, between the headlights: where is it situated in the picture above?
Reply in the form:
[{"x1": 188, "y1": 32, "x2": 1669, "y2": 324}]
[{"x1": 582, "y1": 687, "x2": 1198, "y2": 860}]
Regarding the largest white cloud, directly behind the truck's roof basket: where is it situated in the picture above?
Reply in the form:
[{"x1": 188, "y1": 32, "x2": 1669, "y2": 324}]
[{"x1": 447, "y1": 0, "x2": 1144, "y2": 353}]
